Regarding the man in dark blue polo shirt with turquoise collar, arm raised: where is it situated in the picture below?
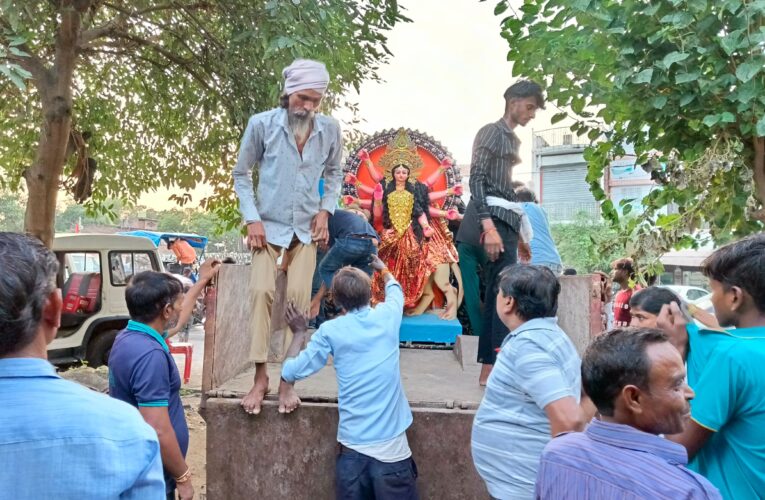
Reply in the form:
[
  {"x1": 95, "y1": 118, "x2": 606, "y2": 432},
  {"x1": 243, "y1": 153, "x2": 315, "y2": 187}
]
[{"x1": 109, "y1": 261, "x2": 217, "y2": 500}]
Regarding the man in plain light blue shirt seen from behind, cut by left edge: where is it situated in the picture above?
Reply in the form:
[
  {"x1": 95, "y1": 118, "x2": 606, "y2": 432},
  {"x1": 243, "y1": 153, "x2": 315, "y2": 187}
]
[{"x1": 0, "y1": 233, "x2": 165, "y2": 500}]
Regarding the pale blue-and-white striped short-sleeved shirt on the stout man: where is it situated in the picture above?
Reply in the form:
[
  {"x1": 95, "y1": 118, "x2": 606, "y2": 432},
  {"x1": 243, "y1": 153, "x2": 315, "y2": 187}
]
[{"x1": 471, "y1": 318, "x2": 582, "y2": 500}]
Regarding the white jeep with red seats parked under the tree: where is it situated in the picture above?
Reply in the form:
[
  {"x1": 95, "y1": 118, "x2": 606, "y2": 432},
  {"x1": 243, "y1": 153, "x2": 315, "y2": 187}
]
[{"x1": 48, "y1": 234, "x2": 163, "y2": 368}]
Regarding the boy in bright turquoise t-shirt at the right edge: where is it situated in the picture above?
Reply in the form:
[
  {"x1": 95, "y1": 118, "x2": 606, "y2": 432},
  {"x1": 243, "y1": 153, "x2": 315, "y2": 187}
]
[{"x1": 658, "y1": 234, "x2": 765, "y2": 500}]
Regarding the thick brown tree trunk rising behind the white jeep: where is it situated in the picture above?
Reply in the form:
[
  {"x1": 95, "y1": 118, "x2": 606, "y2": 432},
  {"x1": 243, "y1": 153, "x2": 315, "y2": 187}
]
[{"x1": 24, "y1": 0, "x2": 88, "y2": 246}]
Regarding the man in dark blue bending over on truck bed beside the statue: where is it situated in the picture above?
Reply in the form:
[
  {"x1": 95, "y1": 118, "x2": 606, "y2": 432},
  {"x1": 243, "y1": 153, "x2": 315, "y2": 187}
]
[{"x1": 310, "y1": 205, "x2": 380, "y2": 318}]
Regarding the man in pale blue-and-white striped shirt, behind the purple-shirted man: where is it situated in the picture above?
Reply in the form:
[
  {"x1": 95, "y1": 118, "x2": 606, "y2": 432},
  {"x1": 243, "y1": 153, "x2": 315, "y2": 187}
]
[{"x1": 471, "y1": 264, "x2": 594, "y2": 500}]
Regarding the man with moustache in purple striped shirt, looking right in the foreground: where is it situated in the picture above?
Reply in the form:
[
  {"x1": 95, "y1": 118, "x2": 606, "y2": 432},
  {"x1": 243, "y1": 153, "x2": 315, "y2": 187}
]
[{"x1": 536, "y1": 328, "x2": 722, "y2": 500}]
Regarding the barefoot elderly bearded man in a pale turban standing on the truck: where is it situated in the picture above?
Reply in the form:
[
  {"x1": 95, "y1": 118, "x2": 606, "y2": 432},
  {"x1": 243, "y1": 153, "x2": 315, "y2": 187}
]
[{"x1": 234, "y1": 59, "x2": 343, "y2": 414}]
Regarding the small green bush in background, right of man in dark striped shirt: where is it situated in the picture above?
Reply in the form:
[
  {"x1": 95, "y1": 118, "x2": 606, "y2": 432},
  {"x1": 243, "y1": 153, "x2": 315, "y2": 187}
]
[{"x1": 550, "y1": 212, "x2": 623, "y2": 273}]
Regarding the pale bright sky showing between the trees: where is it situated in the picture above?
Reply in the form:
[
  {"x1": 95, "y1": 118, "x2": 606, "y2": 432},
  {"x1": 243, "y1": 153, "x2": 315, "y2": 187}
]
[{"x1": 139, "y1": 0, "x2": 556, "y2": 209}]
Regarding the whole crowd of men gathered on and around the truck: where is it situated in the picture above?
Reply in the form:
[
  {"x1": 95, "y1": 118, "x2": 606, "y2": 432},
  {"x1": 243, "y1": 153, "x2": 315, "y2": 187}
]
[{"x1": 0, "y1": 56, "x2": 765, "y2": 500}]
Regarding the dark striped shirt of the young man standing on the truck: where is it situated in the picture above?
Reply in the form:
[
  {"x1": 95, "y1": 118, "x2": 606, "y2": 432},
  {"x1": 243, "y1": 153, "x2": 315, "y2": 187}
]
[{"x1": 470, "y1": 119, "x2": 521, "y2": 232}]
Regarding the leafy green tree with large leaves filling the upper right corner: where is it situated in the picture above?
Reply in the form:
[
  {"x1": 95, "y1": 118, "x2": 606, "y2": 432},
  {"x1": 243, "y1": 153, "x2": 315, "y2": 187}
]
[{"x1": 495, "y1": 0, "x2": 765, "y2": 259}]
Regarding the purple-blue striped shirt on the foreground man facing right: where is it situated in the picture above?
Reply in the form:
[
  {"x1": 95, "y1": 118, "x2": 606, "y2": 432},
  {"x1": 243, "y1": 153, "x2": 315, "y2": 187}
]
[{"x1": 536, "y1": 420, "x2": 722, "y2": 500}]
